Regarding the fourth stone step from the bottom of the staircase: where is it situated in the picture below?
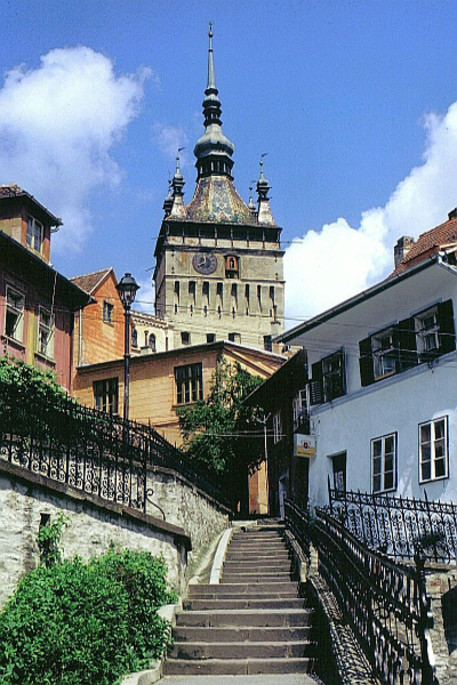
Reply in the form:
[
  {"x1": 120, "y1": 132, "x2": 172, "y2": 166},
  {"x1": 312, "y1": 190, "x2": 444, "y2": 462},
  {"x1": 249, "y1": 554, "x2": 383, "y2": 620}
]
[{"x1": 176, "y1": 607, "x2": 312, "y2": 628}]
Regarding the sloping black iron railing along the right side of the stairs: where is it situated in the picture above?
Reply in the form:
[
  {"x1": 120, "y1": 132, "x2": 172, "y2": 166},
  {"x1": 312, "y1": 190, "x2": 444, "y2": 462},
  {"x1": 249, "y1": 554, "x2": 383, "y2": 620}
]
[{"x1": 286, "y1": 502, "x2": 437, "y2": 685}]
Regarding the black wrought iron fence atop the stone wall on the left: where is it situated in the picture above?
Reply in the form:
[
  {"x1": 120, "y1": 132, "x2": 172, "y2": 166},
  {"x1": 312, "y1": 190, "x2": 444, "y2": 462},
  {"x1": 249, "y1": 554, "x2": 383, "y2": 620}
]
[{"x1": 0, "y1": 381, "x2": 227, "y2": 512}]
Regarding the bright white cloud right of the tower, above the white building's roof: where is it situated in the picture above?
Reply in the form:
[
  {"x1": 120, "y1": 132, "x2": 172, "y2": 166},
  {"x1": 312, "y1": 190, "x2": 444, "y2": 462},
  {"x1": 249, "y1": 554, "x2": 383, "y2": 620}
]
[{"x1": 284, "y1": 102, "x2": 457, "y2": 323}]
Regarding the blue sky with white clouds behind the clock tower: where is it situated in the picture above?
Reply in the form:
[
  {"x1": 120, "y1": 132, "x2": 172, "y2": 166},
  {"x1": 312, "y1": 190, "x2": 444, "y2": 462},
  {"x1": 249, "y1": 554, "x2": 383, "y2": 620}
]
[{"x1": 0, "y1": 0, "x2": 457, "y2": 328}]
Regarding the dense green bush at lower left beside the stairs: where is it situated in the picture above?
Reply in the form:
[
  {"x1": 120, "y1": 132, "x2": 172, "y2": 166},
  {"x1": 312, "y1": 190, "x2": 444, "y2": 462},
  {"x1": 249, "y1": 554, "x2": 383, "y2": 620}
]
[{"x1": 0, "y1": 549, "x2": 175, "y2": 685}]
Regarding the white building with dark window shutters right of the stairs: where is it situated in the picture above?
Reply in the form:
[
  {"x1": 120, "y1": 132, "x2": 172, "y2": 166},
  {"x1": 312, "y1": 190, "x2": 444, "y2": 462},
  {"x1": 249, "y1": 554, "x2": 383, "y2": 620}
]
[{"x1": 280, "y1": 212, "x2": 457, "y2": 505}]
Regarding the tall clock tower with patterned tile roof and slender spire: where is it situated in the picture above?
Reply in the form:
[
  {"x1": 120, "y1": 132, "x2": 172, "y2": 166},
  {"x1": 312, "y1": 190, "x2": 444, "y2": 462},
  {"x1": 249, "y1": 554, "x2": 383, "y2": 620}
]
[{"x1": 153, "y1": 25, "x2": 284, "y2": 350}]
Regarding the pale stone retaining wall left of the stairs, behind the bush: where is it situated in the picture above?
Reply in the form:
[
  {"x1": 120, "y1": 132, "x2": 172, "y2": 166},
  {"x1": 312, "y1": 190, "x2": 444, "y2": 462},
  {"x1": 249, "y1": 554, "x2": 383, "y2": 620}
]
[{"x1": 0, "y1": 460, "x2": 228, "y2": 604}]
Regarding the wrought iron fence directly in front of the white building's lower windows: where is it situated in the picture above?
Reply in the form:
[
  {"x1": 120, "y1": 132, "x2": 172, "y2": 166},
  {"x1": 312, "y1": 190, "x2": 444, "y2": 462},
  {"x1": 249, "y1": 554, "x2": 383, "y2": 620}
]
[{"x1": 329, "y1": 486, "x2": 457, "y2": 563}]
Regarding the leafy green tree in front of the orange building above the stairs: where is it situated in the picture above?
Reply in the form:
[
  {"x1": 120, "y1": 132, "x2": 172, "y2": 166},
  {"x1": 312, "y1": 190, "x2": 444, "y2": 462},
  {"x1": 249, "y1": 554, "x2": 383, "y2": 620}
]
[{"x1": 179, "y1": 359, "x2": 263, "y2": 502}]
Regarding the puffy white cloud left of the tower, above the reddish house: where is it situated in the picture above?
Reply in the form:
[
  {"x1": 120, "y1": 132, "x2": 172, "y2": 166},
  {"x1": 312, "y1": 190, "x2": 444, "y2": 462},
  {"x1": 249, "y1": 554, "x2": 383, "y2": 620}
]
[{"x1": 0, "y1": 46, "x2": 150, "y2": 250}]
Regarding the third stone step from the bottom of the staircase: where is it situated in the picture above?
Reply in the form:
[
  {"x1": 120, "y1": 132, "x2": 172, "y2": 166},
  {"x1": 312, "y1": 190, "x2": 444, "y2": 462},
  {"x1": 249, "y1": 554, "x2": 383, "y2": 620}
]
[{"x1": 173, "y1": 625, "x2": 311, "y2": 643}]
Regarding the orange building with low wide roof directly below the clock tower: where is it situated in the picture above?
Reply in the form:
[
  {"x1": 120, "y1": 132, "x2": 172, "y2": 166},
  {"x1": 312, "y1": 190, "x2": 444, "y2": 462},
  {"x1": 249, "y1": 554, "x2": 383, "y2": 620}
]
[{"x1": 74, "y1": 341, "x2": 285, "y2": 513}]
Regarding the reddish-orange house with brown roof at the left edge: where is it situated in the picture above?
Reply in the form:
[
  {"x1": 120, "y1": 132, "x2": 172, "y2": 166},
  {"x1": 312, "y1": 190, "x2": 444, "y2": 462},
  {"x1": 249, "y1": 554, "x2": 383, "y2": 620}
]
[{"x1": 0, "y1": 185, "x2": 89, "y2": 390}]
